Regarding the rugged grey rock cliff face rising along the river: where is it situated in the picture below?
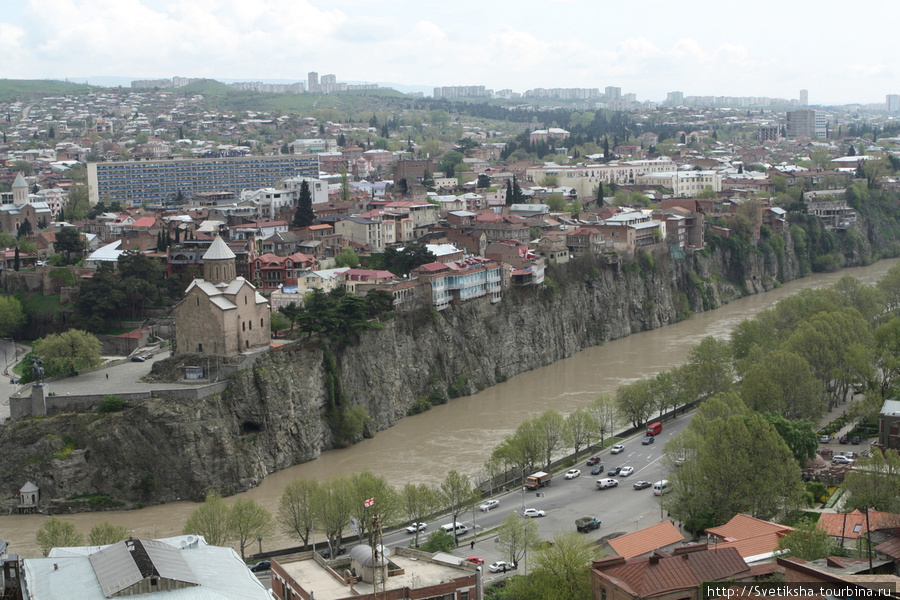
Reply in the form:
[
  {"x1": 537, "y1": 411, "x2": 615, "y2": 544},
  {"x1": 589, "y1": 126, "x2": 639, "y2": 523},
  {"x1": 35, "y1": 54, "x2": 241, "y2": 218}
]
[{"x1": 0, "y1": 227, "x2": 856, "y2": 502}]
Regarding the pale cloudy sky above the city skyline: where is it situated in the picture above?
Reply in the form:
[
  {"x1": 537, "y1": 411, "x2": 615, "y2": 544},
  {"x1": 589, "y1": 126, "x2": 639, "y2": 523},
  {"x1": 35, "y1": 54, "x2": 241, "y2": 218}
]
[{"x1": 0, "y1": 0, "x2": 900, "y2": 105}]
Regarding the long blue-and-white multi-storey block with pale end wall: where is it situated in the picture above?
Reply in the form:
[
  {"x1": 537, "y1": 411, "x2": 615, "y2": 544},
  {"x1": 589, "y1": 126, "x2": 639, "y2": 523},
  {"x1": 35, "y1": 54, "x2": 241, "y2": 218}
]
[{"x1": 87, "y1": 154, "x2": 319, "y2": 206}]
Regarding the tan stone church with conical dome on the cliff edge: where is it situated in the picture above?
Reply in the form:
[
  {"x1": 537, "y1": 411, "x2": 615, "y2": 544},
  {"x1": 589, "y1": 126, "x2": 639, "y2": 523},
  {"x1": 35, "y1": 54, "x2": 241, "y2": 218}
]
[{"x1": 175, "y1": 236, "x2": 271, "y2": 356}]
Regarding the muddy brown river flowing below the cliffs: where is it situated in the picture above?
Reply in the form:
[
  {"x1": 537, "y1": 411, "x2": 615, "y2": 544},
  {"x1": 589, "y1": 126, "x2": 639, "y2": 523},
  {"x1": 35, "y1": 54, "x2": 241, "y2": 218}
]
[{"x1": 0, "y1": 259, "x2": 900, "y2": 557}]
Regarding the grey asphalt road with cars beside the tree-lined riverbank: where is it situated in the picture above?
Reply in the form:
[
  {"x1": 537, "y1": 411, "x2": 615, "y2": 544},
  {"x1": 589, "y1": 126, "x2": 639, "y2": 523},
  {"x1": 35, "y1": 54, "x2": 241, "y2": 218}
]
[{"x1": 376, "y1": 413, "x2": 693, "y2": 581}]
